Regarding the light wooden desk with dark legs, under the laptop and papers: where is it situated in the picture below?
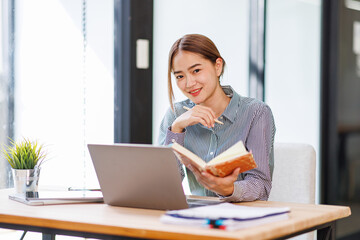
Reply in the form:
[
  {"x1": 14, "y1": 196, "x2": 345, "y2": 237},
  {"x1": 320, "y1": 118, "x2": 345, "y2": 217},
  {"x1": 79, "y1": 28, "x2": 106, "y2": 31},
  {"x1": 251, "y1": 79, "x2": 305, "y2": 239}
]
[{"x1": 0, "y1": 189, "x2": 351, "y2": 239}]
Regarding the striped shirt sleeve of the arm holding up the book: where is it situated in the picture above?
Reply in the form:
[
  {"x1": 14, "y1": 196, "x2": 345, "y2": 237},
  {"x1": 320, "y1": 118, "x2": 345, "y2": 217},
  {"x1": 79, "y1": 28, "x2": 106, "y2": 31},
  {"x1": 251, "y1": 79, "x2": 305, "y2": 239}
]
[{"x1": 220, "y1": 105, "x2": 276, "y2": 202}]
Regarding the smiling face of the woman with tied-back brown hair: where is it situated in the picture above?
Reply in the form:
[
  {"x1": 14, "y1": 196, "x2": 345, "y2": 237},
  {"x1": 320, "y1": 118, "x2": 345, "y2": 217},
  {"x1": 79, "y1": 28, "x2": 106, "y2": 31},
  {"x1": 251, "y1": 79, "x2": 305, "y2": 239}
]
[{"x1": 173, "y1": 51, "x2": 223, "y2": 104}]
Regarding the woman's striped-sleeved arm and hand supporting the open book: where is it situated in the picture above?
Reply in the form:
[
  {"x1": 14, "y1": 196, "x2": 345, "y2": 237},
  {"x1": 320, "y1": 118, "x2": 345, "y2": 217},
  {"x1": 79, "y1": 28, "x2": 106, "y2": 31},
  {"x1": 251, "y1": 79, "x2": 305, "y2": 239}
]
[{"x1": 187, "y1": 105, "x2": 275, "y2": 202}]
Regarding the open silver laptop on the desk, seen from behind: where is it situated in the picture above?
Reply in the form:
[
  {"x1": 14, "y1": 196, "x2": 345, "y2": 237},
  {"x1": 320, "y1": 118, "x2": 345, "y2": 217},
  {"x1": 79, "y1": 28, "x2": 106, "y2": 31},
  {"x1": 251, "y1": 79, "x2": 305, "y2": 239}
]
[{"x1": 88, "y1": 144, "x2": 220, "y2": 210}]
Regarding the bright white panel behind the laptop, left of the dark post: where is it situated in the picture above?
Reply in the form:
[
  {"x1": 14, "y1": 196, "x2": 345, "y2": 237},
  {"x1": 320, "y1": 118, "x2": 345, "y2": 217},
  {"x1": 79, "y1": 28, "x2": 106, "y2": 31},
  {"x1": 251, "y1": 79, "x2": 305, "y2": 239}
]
[{"x1": 15, "y1": 0, "x2": 114, "y2": 186}]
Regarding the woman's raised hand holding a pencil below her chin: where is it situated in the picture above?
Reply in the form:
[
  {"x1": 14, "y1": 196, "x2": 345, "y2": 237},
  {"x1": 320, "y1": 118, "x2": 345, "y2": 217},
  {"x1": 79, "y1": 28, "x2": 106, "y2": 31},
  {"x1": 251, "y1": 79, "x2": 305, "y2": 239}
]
[{"x1": 171, "y1": 105, "x2": 215, "y2": 133}]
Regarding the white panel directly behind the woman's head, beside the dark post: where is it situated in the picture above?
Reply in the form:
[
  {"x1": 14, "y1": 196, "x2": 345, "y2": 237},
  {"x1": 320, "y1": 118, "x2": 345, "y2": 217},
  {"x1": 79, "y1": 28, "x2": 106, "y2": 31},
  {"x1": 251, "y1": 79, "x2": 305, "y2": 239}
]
[{"x1": 153, "y1": 0, "x2": 249, "y2": 143}]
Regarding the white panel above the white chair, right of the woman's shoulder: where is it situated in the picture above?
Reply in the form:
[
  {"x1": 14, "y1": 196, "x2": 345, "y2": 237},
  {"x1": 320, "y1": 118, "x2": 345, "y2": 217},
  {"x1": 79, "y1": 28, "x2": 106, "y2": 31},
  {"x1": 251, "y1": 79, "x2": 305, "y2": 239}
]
[{"x1": 265, "y1": 0, "x2": 321, "y2": 201}]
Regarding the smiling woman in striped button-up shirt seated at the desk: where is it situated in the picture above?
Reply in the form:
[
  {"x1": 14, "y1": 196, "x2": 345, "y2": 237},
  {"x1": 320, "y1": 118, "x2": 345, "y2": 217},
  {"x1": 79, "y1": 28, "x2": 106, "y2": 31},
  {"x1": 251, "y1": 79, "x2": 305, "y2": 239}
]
[{"x1": 159, "y1": 34, "x2": 275, "y2": 202}]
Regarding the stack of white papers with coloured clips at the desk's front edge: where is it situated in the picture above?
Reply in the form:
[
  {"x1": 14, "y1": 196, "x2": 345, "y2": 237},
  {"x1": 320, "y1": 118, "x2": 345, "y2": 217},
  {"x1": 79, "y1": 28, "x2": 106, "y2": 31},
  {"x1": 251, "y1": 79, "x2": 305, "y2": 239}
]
[{"x1": 160, "y1": 203, "x2": 290, "y2": 230}]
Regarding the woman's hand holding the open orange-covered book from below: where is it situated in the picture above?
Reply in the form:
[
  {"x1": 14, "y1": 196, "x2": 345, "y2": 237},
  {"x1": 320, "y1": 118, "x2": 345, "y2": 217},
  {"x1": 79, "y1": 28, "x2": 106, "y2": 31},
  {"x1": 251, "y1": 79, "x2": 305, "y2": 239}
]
[{"x1": 187, "y1": 164, "x2": 240, "y2": 196}]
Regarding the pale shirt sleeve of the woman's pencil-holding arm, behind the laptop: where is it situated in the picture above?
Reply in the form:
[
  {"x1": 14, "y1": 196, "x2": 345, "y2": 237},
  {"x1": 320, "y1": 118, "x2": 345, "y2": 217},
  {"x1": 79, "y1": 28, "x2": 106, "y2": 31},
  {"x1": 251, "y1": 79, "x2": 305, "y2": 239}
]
[{"x1": 158, "y1": 108, "x2": 185, "y2": 179}]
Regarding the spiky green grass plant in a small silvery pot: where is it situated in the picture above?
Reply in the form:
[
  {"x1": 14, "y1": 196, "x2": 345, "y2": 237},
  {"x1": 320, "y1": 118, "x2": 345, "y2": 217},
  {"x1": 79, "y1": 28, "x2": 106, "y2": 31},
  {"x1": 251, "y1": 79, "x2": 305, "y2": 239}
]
[{"x1": 2, "y1": 139, "x2": 46, "y2": 194}]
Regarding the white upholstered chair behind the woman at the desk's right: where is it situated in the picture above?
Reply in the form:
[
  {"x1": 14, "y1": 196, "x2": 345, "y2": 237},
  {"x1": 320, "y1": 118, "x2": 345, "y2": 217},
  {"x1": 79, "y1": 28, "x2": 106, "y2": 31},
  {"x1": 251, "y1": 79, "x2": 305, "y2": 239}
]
[{"x1": 269, "y1": 143, "x2": 316, "y2": 239}]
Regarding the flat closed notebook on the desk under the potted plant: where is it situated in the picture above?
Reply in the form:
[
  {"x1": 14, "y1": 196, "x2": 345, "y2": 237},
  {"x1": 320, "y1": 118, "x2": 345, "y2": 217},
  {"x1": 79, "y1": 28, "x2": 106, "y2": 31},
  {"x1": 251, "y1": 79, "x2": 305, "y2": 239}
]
[{"x1": 9, "y1": 191, "x2": 103, "y2": 206}]
